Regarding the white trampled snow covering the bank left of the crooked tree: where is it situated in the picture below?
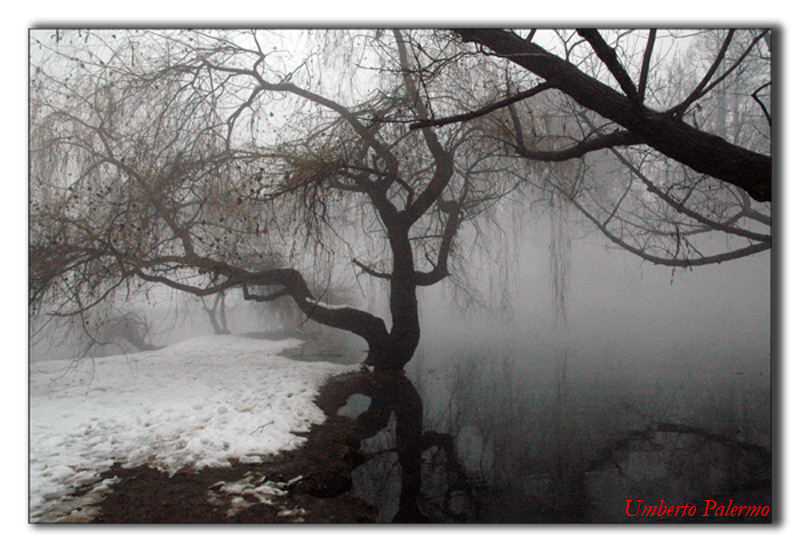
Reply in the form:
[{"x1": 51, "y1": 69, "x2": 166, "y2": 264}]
[{"x1": 30, "y1": 336, "x2": 355, "y2": 521}]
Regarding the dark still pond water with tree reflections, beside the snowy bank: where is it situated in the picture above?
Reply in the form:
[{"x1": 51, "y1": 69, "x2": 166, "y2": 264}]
[{"x1": 339, "y1": 338, "x2": 771, "y2": 523}]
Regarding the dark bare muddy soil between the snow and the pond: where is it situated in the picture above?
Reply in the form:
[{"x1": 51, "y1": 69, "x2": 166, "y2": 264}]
[{"x1": 75, "y1": 334, "x2": 376, "y2": 523}]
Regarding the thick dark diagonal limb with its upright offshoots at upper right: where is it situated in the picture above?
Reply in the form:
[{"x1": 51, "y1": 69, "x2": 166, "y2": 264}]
[{"x1": 446, "y1": 29, "x2": 772, "y2": 201}]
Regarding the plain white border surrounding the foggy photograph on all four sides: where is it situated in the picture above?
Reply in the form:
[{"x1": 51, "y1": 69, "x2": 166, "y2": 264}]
[{"x1": 6, "y1": 0, "x2": 800, "y2": 552}]
